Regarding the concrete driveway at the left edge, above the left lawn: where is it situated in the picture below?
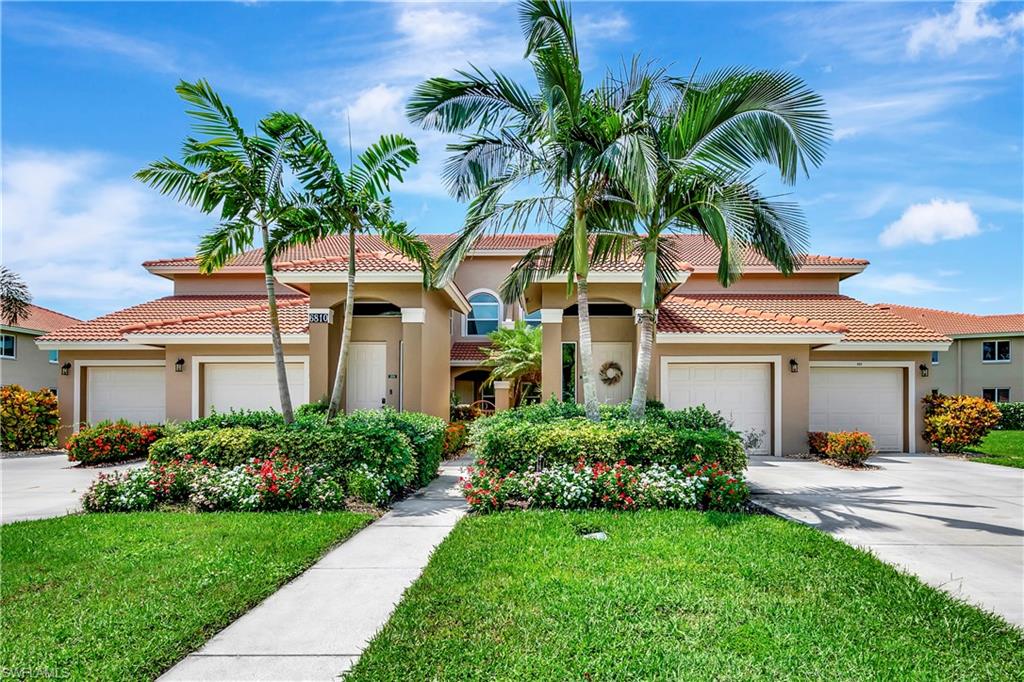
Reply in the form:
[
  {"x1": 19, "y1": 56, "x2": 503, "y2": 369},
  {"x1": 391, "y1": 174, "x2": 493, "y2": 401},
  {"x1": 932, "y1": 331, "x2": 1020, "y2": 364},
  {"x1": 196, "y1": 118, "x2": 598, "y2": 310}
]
[{"x1": 0, "y1": 454, "x2": 139, "y2": 523}]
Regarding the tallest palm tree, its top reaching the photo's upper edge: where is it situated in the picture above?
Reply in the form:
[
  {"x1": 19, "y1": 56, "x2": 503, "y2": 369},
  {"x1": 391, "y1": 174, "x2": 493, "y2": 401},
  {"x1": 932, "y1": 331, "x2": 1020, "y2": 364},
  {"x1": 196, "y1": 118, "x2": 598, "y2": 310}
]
[{"x1": 407, "y1": 0, "x2": 657, "y2": 420}]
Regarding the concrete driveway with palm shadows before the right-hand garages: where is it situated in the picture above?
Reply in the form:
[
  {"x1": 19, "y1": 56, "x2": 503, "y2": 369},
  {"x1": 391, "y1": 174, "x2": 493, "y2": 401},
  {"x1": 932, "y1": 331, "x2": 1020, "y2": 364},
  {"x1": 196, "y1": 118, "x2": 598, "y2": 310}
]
[{"x1": 749, "y1": 455, "x2": 1024, "y2": 626}]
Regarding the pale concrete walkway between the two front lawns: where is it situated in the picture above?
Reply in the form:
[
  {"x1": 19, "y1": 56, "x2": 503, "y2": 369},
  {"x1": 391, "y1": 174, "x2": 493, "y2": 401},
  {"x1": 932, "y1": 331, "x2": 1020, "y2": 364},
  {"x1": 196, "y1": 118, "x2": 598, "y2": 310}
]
[{"x1": 161, "y1": 458, "x2": 470, "y2": 680}]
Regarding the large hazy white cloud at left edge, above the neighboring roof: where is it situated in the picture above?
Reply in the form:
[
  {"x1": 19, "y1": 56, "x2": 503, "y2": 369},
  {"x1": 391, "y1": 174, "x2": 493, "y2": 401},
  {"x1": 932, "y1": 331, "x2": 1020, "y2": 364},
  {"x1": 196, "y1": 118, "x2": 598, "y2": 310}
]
[{"x1": 2, "y1": 150, "x2": 209, "y2": 316}]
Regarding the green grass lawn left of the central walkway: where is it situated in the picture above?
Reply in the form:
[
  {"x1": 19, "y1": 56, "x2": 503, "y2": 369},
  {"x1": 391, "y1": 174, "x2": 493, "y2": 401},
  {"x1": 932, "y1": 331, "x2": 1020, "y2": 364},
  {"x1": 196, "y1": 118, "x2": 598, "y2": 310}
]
[{"x1": 0, "y1": 512, "x2": 370, "y2": 680}]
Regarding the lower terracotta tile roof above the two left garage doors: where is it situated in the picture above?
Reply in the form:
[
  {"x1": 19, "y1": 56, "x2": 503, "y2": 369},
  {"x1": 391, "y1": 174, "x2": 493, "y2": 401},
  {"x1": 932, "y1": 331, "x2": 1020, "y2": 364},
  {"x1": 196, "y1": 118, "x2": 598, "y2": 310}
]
[{"x1": 39, "y1": 294, "x2": 309, "y2": 342}]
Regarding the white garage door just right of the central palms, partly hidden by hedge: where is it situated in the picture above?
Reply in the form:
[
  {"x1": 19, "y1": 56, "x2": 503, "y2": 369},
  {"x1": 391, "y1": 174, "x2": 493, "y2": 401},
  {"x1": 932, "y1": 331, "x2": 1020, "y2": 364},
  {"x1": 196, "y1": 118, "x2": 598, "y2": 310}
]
[{"x1": 664, "y1": 363, "x2": 771, "y2": 455}]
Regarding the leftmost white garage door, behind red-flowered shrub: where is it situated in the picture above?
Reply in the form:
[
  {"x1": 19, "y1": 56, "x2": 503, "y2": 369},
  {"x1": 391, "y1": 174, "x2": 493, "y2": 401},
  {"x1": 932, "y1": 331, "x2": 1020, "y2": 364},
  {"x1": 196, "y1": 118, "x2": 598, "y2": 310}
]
[{"x1": 85, "y1": 367, "x2": 166, "y2": 424}]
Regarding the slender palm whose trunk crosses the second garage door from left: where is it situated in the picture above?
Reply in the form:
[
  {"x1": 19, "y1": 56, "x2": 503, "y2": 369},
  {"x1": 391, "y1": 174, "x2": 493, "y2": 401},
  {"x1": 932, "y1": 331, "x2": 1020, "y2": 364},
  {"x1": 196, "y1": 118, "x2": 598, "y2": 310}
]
[{"x1": 135, "y1": 80, "x2": 294, "y2": 423}]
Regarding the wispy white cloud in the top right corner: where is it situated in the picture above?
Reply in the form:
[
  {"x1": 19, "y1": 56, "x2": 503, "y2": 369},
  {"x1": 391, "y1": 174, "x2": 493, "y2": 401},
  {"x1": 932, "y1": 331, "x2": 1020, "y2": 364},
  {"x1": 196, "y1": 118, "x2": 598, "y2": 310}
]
[{"x1": 906, "y1": 0, "x2": 1024, "y2": 57}]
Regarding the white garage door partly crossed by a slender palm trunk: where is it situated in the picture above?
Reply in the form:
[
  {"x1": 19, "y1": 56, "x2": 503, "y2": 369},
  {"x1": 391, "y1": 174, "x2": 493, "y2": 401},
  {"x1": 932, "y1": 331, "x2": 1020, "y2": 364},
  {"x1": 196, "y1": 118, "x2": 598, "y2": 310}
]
[{"x1": 203, "y1": 363, "x2": 306, "y2": 415}]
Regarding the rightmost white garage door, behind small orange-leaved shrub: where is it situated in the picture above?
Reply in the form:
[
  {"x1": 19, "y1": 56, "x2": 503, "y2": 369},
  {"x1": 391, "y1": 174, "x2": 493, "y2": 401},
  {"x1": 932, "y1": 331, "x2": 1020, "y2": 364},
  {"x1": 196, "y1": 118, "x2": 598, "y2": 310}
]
[{"x1": 810, "y1": 367, "x2": 903, "y2": 453}]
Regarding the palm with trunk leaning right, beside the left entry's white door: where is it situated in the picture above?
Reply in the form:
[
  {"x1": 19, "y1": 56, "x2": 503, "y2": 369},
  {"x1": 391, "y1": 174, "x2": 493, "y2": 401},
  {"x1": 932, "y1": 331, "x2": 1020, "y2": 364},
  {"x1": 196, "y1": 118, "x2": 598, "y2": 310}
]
[{"x1": 268, "y1": 113, "x2": 433, "y2": 420}]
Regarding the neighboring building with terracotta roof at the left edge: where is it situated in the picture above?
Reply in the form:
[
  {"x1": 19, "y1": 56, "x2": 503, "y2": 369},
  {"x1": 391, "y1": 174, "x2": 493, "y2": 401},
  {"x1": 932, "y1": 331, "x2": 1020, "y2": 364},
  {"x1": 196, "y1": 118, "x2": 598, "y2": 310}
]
[{"x1": 0, "y1": 305, "x2": 82, "y2": 390}]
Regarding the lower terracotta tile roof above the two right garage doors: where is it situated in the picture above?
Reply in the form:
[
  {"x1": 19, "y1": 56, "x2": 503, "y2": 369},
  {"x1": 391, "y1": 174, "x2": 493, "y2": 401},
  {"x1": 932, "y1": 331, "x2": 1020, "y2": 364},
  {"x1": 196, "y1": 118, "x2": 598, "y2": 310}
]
[{"x1": 658, "y1": 293, "x2": 948, "y2": 343}]
